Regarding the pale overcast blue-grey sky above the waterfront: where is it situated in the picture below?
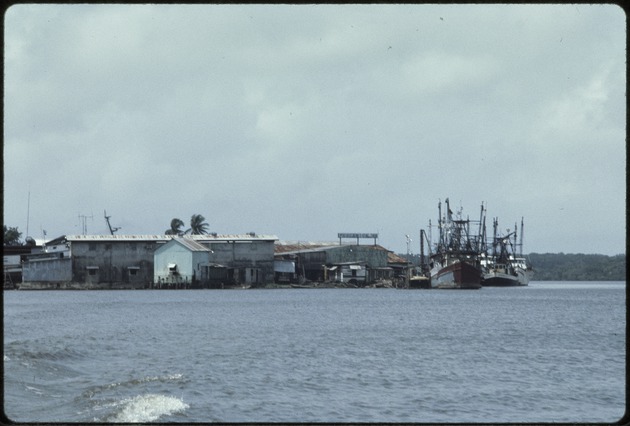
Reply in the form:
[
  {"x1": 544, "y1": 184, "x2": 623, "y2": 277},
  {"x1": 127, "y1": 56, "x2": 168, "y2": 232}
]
[{"x1": 3, "y1": 4, "x2": 626, "y2": 255}]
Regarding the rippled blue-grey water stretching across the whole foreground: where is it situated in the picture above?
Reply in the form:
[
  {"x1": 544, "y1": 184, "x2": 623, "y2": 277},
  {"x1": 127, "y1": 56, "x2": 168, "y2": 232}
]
[{"x1": 4, "y1": 282, "x2": 626, "y2": 422}]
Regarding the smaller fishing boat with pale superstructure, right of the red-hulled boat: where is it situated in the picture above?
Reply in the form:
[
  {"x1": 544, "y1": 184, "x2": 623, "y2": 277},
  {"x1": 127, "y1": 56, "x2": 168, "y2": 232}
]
[{"x1": 481, "y1": 218, "x2": 532, "y2": 287}]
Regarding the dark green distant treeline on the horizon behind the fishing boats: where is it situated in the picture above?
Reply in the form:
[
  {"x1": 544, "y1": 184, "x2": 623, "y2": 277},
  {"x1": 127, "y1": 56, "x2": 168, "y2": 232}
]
[{"x1": 398, "y1": 253, "x2": 626, "y2": 281}]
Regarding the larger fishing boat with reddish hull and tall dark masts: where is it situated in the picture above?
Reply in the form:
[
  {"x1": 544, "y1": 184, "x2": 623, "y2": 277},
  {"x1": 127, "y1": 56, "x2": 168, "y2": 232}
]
[{"x1": 430, "y1": 198, "x2": 485, "y2": 289}]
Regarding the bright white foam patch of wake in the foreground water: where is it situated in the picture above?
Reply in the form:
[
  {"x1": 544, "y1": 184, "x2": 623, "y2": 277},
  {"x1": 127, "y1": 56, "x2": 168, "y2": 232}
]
[{"x1": 112, "y1": 394, "x2": 189, "y2": 423}]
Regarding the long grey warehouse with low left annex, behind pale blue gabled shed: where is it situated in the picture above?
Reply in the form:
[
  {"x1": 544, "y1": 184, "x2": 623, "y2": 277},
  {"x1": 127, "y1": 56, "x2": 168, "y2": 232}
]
[{"x1": 19, "y1": 233, "x2": 277, "y2": 289}]
